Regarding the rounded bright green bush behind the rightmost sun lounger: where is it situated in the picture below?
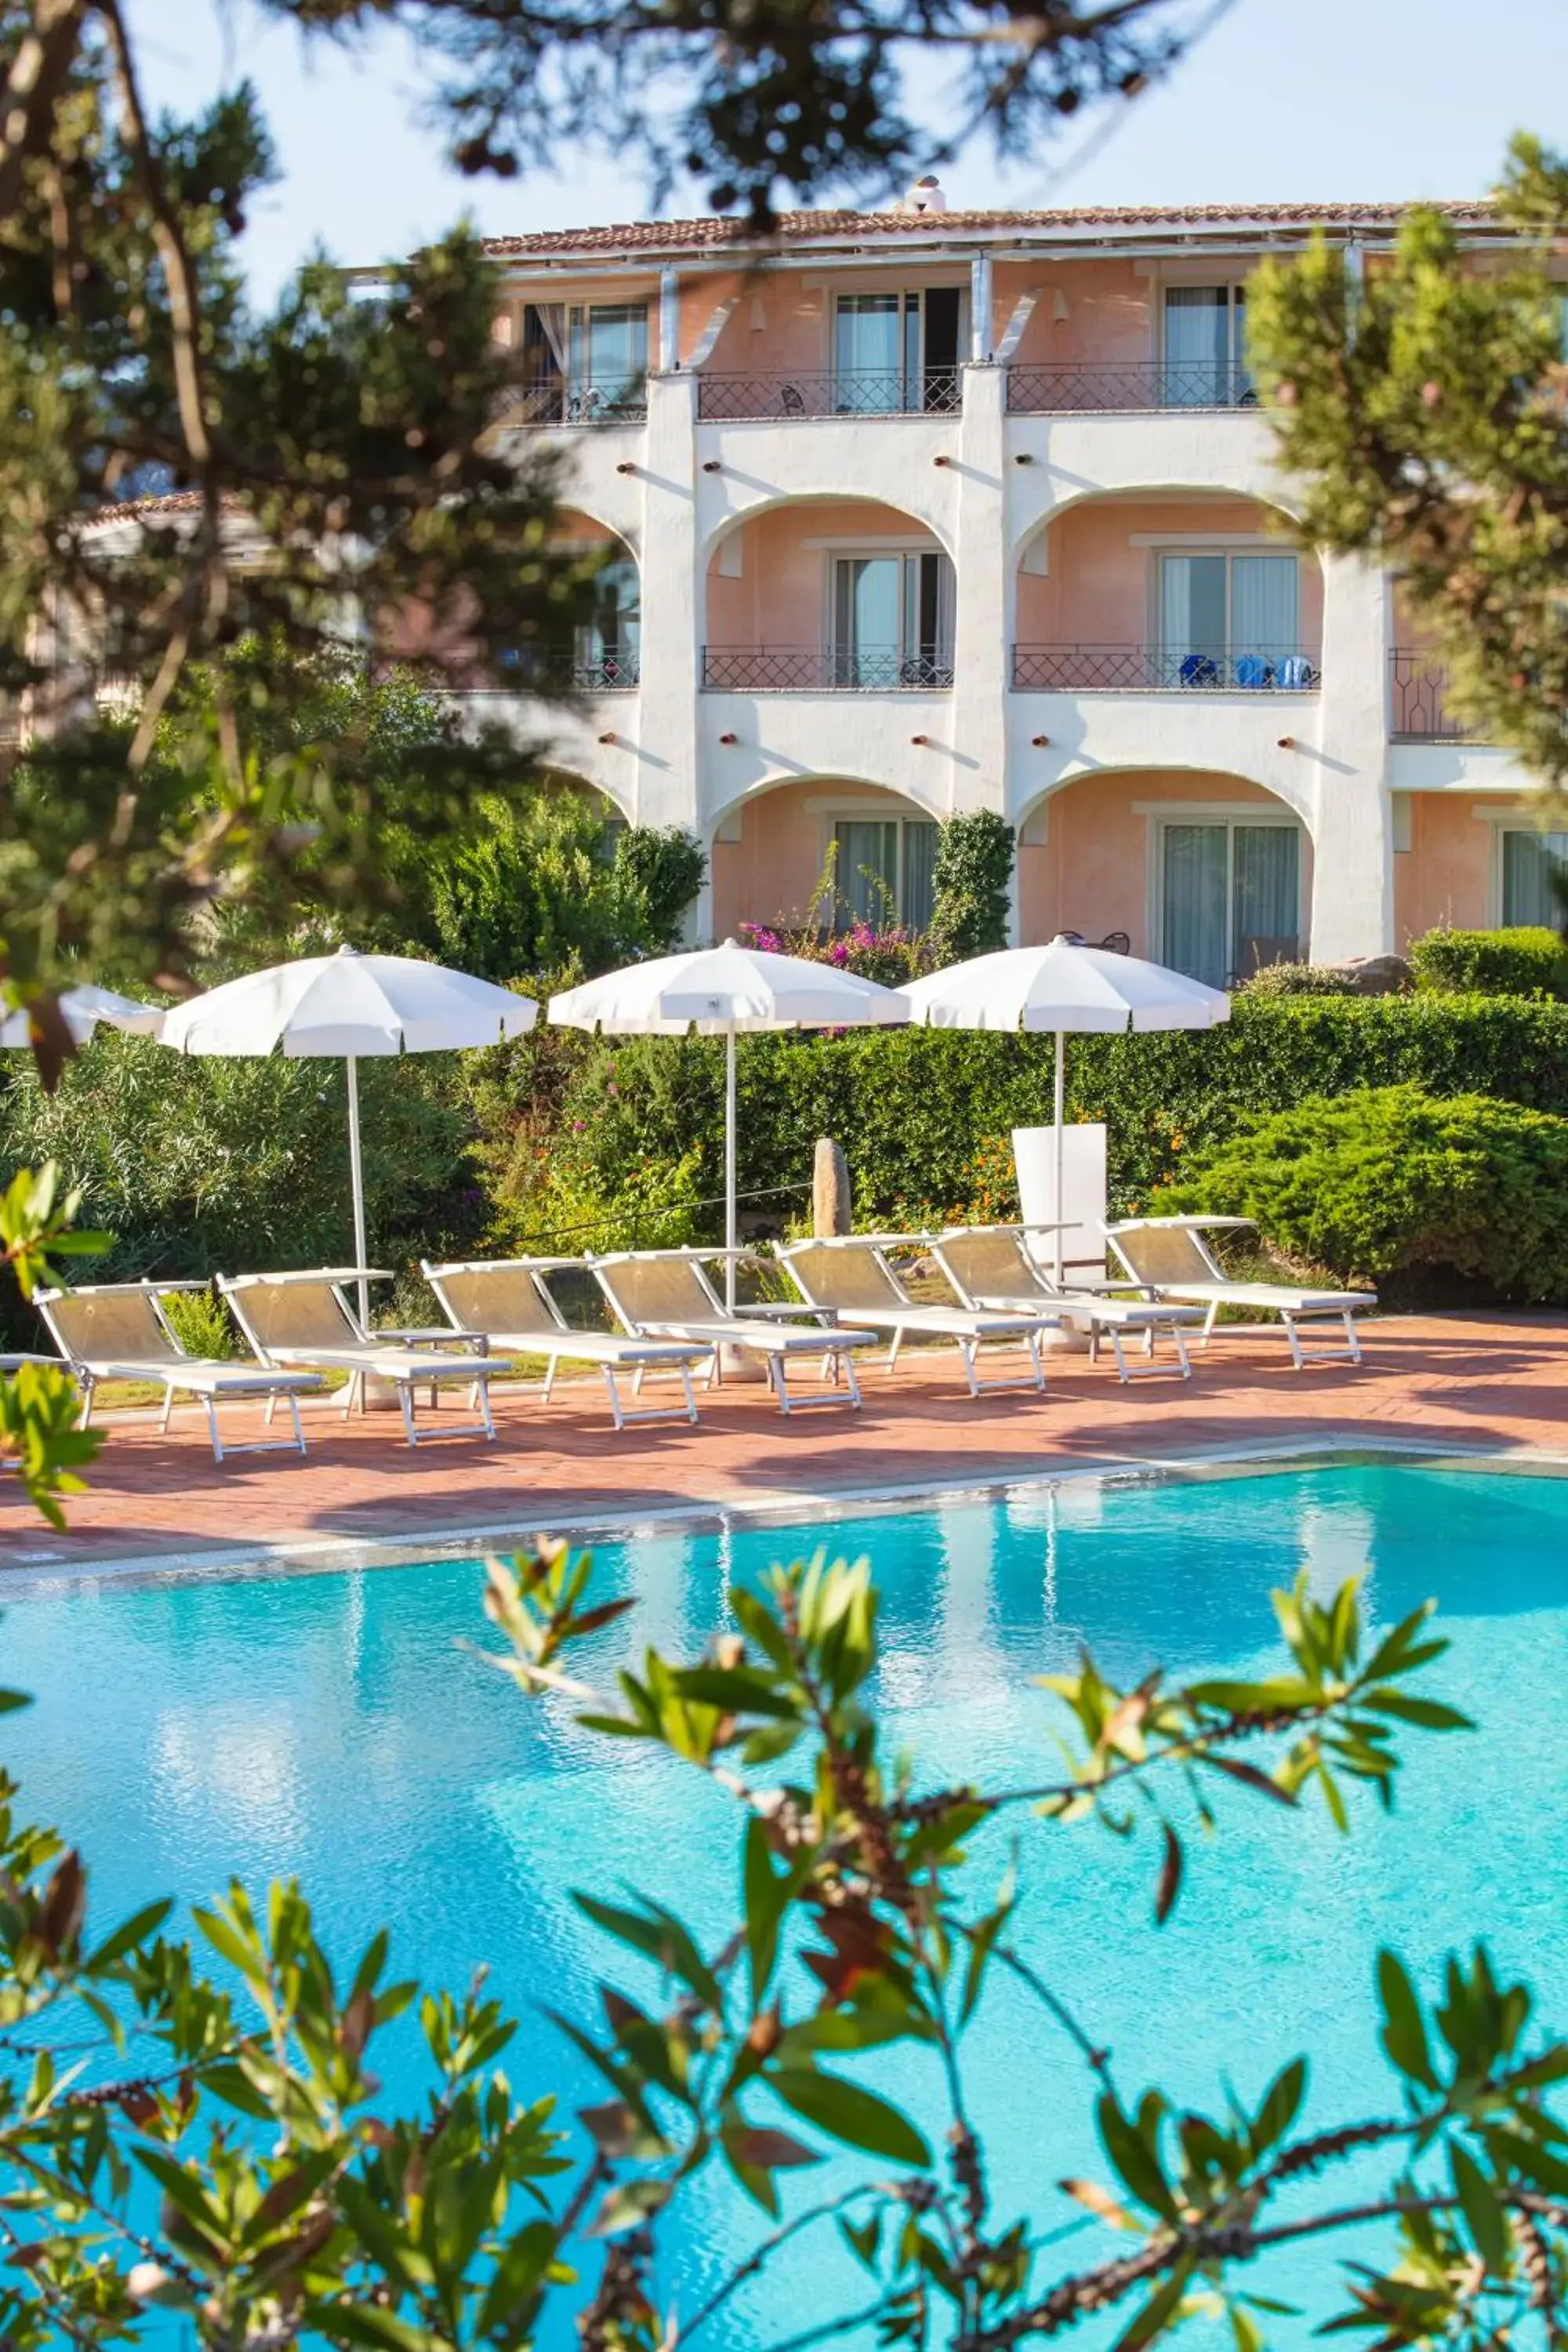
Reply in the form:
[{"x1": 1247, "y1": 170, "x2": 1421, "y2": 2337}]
[{"x1": 1149, "y1": 1087, "x2": 1568, "y2": 1305}]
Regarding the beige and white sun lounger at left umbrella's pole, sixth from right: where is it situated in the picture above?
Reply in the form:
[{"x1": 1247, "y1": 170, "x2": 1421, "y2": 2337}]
[{"x1": 219, "y1": 1265, "x2": 508, "y2": 1446}]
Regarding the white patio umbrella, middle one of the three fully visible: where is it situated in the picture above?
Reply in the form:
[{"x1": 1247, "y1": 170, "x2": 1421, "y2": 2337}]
[{"x1": 550, "y1": 938, "x2": 909, "y2": 1308}]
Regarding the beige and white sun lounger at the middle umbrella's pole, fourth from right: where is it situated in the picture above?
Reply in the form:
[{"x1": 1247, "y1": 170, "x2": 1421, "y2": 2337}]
[{"x1": 588, "y1": 1249, "x2": 872, "y2": 1414}]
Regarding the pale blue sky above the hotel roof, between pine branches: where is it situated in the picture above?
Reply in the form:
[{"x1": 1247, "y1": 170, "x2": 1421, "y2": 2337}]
[{"x1": 132, "y1": 0, "x2": 1568, "y2": 299}]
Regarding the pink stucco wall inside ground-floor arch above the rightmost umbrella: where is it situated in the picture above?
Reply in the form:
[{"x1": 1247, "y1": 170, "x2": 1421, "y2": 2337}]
[{"x1": 1018, "y1": 771, "x2": 1312, "y2": 955}]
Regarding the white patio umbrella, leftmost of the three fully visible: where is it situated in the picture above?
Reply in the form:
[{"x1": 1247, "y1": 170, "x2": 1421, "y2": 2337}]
[{"x1": 160, "y1": 948, "x2": 539, "y2": 1322}]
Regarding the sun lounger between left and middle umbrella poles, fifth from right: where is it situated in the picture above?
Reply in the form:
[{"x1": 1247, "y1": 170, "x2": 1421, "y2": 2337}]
[{"x1": 419, "y1": 1258, "x2": 710, "y2": 1430}]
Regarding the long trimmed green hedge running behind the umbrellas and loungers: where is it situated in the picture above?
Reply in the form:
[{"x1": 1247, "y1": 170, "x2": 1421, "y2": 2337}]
[{"x1": 517, "y1": 995, "x2": 1568, "y2": 1221}]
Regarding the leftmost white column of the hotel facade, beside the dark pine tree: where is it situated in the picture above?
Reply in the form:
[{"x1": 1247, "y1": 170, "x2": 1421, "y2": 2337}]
[{"x1": 637, "y1": 374, "x2": 703, "y2": 833}]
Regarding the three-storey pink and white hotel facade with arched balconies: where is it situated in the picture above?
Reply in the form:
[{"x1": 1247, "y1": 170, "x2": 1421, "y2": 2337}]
[{"x1": 475, "y1": 186, "x2": 1568, "y2": 983}]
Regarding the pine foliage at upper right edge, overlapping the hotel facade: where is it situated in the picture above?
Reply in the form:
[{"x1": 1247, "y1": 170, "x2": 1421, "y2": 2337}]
[{"x1": 1246, "y1": 139, "x2": 1568, "y2": 786}]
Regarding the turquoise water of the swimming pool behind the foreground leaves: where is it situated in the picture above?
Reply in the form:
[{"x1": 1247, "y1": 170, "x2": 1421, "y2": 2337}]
[{"x1": 0, "y1": 1465, "x2": 1568, "y2": 2352}]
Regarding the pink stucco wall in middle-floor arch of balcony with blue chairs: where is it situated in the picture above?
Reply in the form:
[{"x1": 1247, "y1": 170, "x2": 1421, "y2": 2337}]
[{"x1": 1013, "y1": 499, "x2": 1323, "y2": 652}]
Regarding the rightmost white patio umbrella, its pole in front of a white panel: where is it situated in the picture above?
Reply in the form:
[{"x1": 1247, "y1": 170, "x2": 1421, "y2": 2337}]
[{"x1": 898, "y1": 936, "x2": 1229, "y2": 1282}]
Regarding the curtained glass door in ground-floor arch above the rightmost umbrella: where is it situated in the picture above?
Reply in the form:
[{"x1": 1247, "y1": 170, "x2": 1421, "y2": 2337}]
[{"x1": 1159, "y1": 823, "x2": 1300, "y2": 988}]
